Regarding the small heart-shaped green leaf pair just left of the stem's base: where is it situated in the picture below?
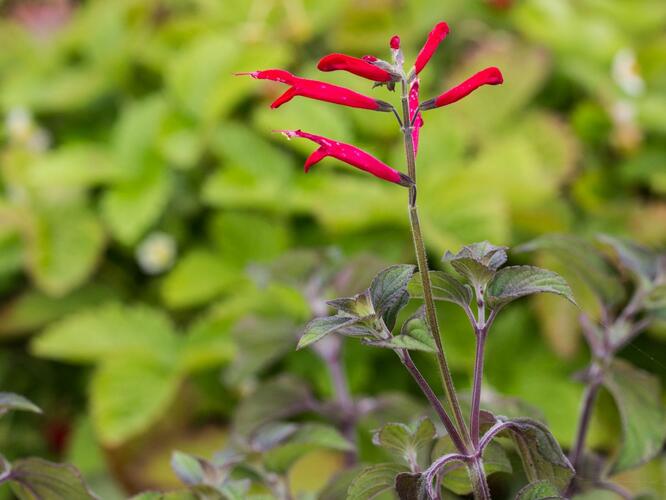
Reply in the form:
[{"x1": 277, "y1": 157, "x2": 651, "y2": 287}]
[{"x1": 372, "y1": 418, "x2": 437, "y2": 471}]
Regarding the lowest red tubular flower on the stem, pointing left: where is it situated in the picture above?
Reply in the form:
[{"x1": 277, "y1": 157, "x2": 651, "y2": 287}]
[{"x1": 279, "y1": 130, "x2": 414, "y2": 186}]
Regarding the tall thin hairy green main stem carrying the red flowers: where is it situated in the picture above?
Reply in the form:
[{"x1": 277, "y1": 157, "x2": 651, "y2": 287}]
[{"x1": 402, "y1": 80, "x2": 470, "y2": 452}]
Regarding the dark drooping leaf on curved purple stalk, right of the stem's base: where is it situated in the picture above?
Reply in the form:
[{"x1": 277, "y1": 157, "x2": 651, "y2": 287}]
[{"x1": 498, "y1": 418, "x2": 574, "y2": 491}]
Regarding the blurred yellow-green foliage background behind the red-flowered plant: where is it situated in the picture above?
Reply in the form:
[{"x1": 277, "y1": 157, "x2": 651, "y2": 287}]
[{"x1": 0, "y1": 0, "x2": 666, "y2": 499}]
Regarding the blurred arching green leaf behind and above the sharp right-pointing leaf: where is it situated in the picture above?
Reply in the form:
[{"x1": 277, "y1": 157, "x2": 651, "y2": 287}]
[{"x1": 516, "y1": 235, "x2": 625, "y2": 305}]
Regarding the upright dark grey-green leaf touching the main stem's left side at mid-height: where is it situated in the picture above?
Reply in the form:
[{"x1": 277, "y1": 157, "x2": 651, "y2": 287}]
[{"x1": 370, "y1": 264, "x2": 416, "y2": 330}]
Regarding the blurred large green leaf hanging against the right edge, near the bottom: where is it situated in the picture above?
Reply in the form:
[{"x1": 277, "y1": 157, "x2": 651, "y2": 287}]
[{"x1": 603, "y1": 359, "x2": 666, "y2": 474}]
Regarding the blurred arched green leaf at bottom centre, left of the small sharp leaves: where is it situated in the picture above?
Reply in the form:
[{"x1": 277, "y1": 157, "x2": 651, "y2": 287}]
[{"x1": 264, "y1": 424, "x2": 354, "y2": 473}]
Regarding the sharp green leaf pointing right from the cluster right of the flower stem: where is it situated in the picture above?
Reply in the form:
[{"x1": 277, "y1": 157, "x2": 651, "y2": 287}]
[{"x1": 486, "y1": 266, "x2": 576, "y2": 309}]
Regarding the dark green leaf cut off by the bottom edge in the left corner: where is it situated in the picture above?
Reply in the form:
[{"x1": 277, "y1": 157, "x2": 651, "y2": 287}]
[{"x1": 9, "y1": 458, "x2": 97, "y2": 500}]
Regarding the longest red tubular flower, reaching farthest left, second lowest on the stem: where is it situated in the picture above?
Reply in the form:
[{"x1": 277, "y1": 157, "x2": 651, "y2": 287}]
[{"x1": 236, "y1": 69, "x2": 393, "y2": 111}]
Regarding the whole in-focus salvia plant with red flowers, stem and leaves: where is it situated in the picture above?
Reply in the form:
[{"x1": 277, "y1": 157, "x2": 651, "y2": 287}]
[{"x1": 235, "y1": 22, "x2": 574, "y2": 499}]
